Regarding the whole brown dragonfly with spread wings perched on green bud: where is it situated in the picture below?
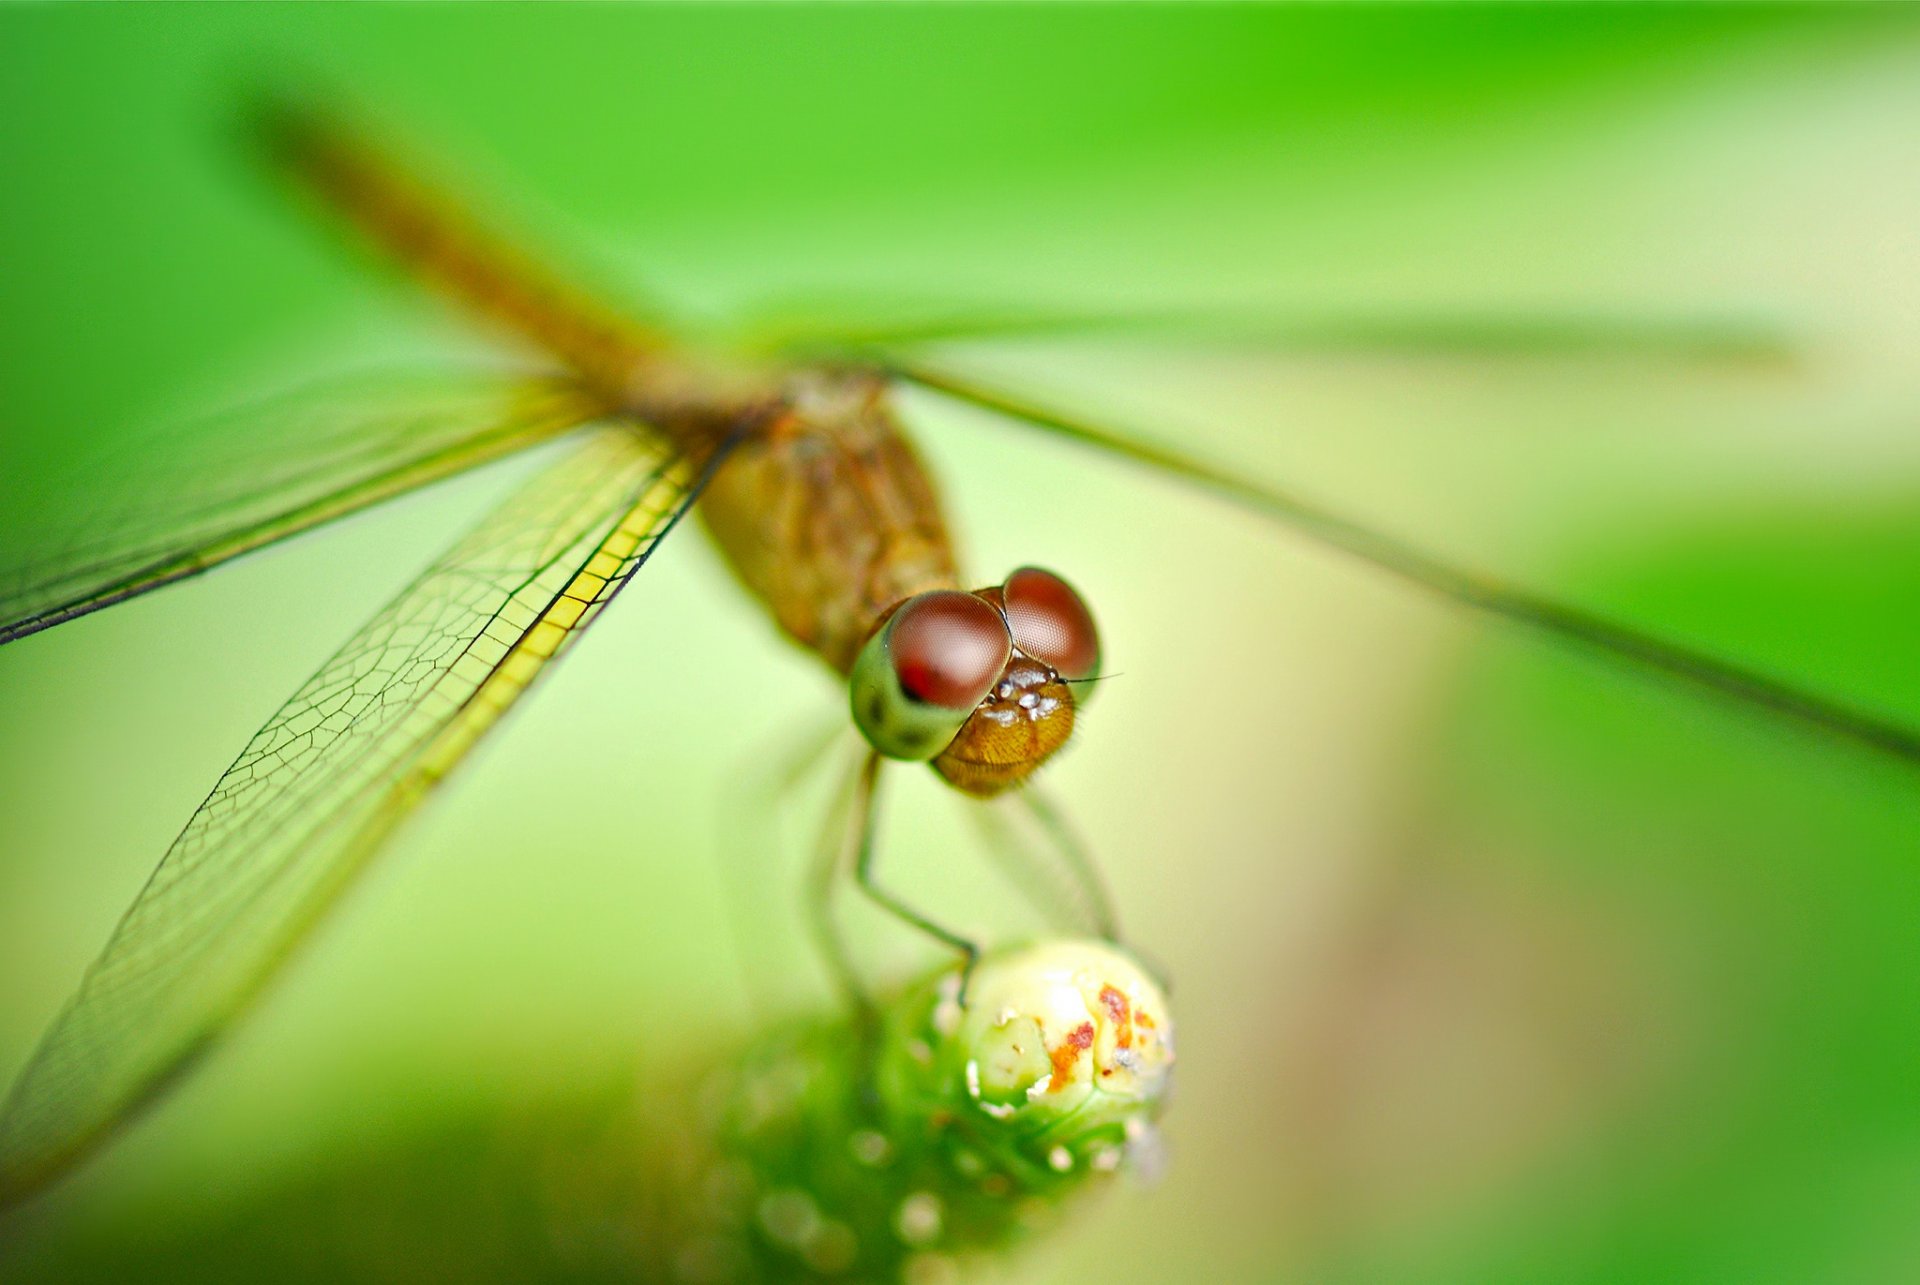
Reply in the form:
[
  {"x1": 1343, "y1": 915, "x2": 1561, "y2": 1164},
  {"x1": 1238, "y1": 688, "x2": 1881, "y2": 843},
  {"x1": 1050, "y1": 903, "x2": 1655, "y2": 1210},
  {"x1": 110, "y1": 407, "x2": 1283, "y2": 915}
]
[{"x1": 0, "y1": 98, "x2": 1920, "y2": 1206}]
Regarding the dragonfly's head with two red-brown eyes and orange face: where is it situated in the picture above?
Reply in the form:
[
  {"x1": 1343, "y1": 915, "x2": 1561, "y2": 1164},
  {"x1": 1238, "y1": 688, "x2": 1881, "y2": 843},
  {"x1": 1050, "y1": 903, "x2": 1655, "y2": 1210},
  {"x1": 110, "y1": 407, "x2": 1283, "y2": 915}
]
[{"x1": 852, "y1": 567, "x2": 1100, "y2": 795}]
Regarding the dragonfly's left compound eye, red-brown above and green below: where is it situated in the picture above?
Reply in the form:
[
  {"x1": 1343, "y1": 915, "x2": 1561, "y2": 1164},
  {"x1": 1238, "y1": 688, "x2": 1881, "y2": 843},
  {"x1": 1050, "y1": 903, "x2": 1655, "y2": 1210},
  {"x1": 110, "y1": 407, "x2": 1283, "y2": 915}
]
[{"x1": 852, "y1": 590, "x2": 1014, "y2": 759}]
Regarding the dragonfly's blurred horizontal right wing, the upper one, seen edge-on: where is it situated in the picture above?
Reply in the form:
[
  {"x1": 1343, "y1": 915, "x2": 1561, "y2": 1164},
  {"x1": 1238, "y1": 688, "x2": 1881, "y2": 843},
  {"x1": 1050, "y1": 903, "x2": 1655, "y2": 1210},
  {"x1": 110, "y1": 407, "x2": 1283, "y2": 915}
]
[{"x1": 747, "y1": 293, "x2": 1795, "y2": 367}]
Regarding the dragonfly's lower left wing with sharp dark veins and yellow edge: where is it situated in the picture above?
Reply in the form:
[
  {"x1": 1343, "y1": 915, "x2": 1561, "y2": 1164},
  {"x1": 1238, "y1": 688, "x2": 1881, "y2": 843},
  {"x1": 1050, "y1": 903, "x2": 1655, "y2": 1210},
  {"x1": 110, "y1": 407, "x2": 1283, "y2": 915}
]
[{"x1": 0, "y1": 424, "x2": 718, "y2": 1206}]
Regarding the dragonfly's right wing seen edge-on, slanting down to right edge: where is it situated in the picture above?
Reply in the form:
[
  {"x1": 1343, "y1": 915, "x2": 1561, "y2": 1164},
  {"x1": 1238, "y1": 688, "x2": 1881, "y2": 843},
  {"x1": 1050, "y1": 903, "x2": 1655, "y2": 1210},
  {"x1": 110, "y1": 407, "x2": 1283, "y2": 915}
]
[{"x1": 885, "y1": 359, "x2": 1920, "y2": 763}]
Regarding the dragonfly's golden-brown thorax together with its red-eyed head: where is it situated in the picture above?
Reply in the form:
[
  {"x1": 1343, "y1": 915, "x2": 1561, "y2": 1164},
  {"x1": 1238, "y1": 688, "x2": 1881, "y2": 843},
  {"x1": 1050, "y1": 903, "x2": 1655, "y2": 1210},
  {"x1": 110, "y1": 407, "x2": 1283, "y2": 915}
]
[{"x1": 675, "y1": 355, "x2": 1100, "y2": 795}]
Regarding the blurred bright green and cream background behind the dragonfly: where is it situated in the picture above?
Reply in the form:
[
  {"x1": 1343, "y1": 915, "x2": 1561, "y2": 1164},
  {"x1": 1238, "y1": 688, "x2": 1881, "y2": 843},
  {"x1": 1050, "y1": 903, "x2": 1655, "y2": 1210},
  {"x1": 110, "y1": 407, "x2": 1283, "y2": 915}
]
[{"x1": 0, "y1": 6, "x2": 1920, "y2": 1281}]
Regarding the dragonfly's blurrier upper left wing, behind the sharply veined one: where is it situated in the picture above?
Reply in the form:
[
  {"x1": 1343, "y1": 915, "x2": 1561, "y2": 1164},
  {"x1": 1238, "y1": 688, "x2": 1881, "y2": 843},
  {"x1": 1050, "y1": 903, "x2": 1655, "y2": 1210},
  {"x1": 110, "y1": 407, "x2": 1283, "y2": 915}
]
[{"x1": 0, "y1": 375, "x2": 599, "y2": 643}]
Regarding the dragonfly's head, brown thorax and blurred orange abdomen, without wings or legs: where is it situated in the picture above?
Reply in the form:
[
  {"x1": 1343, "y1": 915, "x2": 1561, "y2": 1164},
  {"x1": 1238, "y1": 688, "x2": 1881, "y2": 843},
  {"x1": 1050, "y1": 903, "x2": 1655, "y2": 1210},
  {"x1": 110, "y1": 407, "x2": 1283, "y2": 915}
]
[{"x1": 280, "y1": 108, "x2": 1098, "y2": 793}]
